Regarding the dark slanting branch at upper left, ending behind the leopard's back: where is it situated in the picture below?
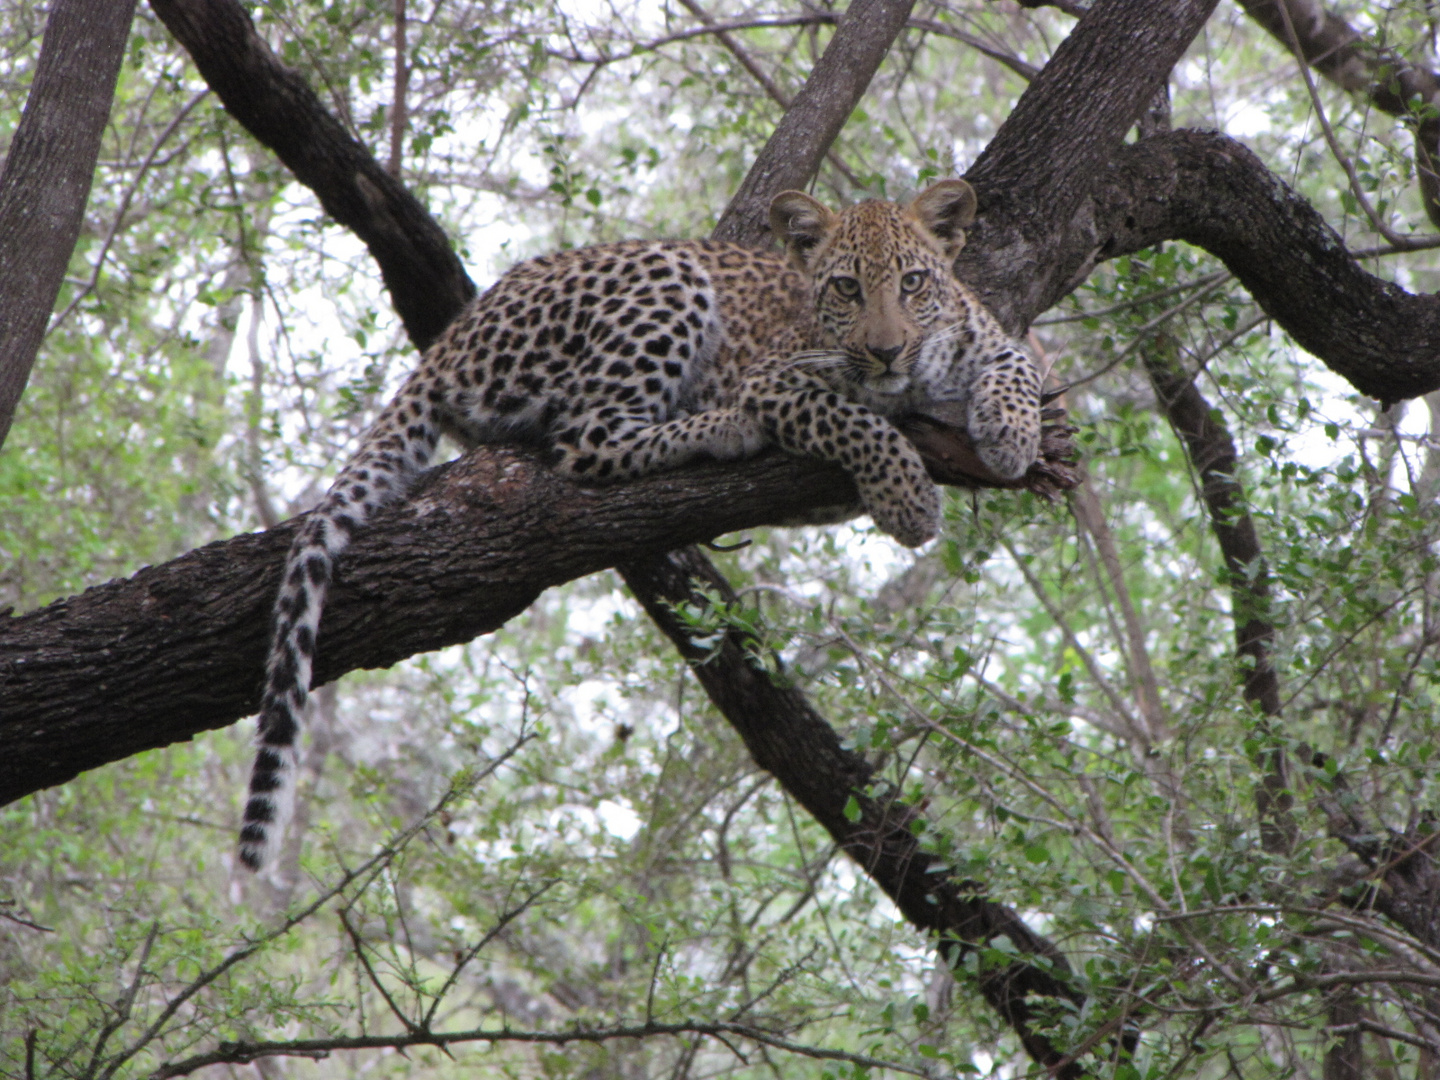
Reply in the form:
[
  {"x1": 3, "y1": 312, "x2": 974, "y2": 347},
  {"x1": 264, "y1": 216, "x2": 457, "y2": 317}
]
[{"x1": 150, "y1": 0, "x2": 475, "y2": 348}]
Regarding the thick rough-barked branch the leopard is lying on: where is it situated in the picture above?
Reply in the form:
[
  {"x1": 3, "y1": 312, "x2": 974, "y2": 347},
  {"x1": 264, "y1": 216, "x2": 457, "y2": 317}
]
[{"x1": 0, "y1": 448, "x2": 855, "y2": 804}]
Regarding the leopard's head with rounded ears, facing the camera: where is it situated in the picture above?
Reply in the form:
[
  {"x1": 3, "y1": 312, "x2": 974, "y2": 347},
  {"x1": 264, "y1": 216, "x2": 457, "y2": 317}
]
[{"x1": 770, "y1": 180, "x2": 975, "y2": 395}]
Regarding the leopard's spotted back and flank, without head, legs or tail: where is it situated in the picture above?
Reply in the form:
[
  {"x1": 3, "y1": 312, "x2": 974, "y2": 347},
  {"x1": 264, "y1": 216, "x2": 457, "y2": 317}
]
[{"x1": 417, "y1": 240, "x2": 808, "y2": 457}]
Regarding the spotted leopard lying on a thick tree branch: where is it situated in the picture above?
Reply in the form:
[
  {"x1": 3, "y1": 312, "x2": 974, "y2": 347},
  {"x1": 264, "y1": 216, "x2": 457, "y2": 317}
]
[{"x1": 239, "y1": 180, "x2": 1041, "y2": 870}]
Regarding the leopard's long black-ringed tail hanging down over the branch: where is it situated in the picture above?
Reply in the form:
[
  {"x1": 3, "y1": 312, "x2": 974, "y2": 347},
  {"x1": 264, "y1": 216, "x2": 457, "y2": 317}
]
[{"x1": 239, "y1": 383, "x2": 439, "y2": 870}]
